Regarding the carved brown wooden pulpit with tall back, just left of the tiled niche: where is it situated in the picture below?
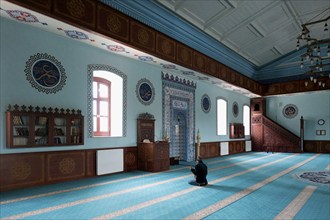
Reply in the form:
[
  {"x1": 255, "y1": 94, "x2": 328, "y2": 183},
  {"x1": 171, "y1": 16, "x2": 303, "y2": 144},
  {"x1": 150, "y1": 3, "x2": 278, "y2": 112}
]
[{"x1": 137, "y1": 113, "x2": 170, "y2": 172}]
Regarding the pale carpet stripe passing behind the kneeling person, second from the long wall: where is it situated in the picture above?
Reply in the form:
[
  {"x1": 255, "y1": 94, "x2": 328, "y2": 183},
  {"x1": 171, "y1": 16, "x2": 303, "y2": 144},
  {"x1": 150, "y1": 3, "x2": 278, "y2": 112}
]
[{"x1": 1, "y1": 154, "x2": 272, "y2": 219}]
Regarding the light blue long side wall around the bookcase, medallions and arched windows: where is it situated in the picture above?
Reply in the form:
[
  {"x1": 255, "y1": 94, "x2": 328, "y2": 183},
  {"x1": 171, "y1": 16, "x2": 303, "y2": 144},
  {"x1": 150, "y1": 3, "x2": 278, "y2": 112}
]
[{"x1": 0, "y1": 18, "x2": 249, "y2": 153}]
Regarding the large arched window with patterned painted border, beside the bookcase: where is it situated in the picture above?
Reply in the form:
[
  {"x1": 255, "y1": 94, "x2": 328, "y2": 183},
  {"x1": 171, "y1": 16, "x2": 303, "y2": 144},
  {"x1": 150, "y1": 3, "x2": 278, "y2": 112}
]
[{"x1": 88, "y1": 64, "x2": 127, "y2": 137}]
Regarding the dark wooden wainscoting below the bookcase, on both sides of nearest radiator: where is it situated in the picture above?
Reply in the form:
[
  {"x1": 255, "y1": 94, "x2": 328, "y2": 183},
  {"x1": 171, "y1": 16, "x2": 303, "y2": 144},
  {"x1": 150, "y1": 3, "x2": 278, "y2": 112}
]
[{"x1": 0, "y1": 146, "x2": 137, "y2": 191}]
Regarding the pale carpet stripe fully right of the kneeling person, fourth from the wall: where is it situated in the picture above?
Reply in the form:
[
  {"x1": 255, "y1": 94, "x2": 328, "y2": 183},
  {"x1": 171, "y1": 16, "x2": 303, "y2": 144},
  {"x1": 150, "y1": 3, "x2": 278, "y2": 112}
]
[{"x1": 184, "y1": 154, "x2": 319, "y2": 219}]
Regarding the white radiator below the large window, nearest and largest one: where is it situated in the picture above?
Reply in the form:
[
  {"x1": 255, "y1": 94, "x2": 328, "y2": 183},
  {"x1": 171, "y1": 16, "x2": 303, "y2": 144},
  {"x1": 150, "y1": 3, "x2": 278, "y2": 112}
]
[{"x1": 96, "y1": 149, "x2": 124, "y2": 175}]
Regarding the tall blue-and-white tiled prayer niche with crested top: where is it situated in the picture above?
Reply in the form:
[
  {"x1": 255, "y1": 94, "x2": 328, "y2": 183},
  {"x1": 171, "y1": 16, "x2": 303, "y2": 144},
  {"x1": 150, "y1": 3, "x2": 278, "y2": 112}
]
[{"x1": 162, "y1": 72, "x2": 196, "y2": 161}]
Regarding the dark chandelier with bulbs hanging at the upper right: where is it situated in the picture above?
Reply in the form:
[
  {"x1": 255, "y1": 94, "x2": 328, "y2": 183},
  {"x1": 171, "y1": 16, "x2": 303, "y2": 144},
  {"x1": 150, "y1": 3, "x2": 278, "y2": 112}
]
[{"x1": 297, "y1": 13, "x2": 330, "y2": 88}]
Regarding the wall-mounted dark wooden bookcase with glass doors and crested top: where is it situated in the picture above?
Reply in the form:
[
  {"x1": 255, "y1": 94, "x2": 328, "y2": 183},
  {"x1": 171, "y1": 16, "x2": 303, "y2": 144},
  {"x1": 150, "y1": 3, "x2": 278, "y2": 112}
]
[{"x1": 6, "y1": 105, "x2": 84, "y2": 148}]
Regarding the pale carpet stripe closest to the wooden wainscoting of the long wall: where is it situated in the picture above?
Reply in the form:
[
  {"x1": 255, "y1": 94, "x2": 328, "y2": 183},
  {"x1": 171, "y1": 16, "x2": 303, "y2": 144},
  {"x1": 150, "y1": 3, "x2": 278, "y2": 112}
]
[{"x1": 0, "y1": 153, "x2": 260, "y2": 205}]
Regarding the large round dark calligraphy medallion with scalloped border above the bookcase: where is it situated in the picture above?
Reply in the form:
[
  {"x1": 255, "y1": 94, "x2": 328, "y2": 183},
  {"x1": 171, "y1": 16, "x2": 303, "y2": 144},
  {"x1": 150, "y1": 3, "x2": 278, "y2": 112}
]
[{"x1": 24, "y1": 53, "x2": 66, "y2": 94}]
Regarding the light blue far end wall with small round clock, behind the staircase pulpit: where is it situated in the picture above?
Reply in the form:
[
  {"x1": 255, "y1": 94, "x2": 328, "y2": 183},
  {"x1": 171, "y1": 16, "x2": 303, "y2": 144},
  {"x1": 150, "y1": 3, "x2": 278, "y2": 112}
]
[{"x1": 266, "y1": 90, "x2": 330, "y2": 140}]
